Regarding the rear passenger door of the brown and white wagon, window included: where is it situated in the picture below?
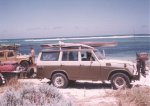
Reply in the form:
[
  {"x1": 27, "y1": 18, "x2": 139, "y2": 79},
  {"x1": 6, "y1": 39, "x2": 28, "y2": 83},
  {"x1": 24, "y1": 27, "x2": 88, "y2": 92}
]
[{"x1": 61, "y1": 51, "x2": 80, "y2": 80}]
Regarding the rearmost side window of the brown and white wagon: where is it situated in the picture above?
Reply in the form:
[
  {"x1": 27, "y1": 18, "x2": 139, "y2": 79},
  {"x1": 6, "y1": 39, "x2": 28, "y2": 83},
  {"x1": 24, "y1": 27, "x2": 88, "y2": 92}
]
[{"x1": 41, "y1": 51, "x2": 59, "y2": 61}]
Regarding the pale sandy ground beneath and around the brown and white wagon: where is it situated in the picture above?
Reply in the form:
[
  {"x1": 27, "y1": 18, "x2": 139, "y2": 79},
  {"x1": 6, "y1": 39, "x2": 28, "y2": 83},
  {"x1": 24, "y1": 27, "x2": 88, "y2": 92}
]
[{"x1": 16, "y1": 68, "x2": 150, "y2": 106}]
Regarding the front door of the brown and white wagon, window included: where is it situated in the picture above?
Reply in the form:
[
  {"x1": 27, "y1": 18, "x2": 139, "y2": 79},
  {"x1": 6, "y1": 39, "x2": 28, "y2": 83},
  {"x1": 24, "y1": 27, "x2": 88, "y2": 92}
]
[{"x1": 80, "y1": 50, "x2": 100, "y2": 80}]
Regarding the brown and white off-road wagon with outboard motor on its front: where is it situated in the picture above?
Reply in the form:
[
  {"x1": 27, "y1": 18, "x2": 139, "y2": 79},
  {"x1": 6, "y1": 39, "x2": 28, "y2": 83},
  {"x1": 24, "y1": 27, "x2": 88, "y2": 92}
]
[{"x1": 37, "y1": 43, "x2": 148, "y2": 89}]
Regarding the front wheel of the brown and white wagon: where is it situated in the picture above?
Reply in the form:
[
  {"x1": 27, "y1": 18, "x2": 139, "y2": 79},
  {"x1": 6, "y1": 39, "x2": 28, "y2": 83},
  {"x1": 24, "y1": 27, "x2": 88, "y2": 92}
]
[{"x1": 111, "y1": 73, "x2": 131, "y2": 89}]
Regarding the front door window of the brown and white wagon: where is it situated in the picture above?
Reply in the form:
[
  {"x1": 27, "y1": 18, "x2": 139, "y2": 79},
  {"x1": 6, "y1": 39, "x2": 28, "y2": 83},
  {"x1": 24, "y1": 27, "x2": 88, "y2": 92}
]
[{"x1": 81, "y1": 51, "x2": 95, "y2": 61}]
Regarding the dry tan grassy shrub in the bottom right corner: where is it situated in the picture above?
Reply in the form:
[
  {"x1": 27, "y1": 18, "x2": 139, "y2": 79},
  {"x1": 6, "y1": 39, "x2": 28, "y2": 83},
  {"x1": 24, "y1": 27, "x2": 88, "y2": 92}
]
[{"x1": 107, "y1": 86, "x2": 150, "y2": 106}]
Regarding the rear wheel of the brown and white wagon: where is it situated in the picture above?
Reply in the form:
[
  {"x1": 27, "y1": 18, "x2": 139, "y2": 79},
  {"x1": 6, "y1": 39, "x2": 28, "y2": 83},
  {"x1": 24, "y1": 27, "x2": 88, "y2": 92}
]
[{"x1": 51, "y1": 73, "x2": 68, "y2": 88}]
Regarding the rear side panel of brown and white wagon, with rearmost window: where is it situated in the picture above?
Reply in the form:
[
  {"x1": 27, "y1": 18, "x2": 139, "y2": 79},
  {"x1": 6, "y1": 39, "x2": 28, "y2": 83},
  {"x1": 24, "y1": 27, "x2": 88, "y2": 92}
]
[{"x1": 37, "y1": 51, "x2": 60, "y2": 78}]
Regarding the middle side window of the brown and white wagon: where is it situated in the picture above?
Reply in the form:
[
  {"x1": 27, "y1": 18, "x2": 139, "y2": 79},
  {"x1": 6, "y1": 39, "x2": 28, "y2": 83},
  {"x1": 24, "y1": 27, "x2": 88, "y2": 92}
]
[{"x1": 62, "y1": 51, "x2": 78, "y2": 61}]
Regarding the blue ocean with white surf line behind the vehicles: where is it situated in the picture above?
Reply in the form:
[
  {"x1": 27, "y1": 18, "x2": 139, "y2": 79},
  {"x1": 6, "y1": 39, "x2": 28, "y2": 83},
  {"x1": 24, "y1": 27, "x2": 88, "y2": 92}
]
[{"x1": 0, "y1": 34, "x2": 150, "y2": 60}]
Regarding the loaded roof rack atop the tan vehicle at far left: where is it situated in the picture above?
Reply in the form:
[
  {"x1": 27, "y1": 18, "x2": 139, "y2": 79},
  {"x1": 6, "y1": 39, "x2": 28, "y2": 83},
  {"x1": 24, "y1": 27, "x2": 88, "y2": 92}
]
[{"x1": 0, "y1": 44, "x2": 20, "y2": 50}]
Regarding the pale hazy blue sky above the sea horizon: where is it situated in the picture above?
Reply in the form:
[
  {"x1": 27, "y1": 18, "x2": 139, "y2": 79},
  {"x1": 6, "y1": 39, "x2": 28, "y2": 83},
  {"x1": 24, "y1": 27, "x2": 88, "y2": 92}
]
[{"x1": 0, "y1": 0, "x2": 150, "y2": 39}]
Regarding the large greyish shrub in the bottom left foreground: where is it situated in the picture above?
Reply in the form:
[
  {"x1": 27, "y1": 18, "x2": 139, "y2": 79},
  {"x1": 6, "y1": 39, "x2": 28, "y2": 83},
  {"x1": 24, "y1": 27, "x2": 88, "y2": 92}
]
[{"x1": 0, "y1": 81, "x2": 72, "y2": 106}]
